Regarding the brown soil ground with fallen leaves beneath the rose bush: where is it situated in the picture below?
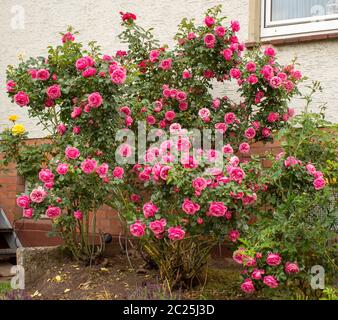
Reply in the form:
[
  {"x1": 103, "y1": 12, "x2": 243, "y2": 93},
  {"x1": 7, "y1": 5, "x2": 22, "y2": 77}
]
[{"x1": 0, "y1": 254, "x2": 264, "y2": 300}]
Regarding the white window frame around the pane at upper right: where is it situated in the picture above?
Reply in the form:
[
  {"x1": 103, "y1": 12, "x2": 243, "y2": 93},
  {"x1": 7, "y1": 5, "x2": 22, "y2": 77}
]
[{"x1": 261, "y1": 0, "x2": 338, "y2": 38}]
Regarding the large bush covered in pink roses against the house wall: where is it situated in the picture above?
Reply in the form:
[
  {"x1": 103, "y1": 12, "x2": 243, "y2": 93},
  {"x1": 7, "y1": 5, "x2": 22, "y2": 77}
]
[{"x1": 7, "y1": 7, "x2": 336, "y2": 293}]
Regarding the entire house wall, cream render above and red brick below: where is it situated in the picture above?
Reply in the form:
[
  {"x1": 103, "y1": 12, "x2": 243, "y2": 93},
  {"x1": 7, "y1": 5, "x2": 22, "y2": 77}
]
[{"x1": 0, "y1": 0, "x2": 338, "y2": 246}]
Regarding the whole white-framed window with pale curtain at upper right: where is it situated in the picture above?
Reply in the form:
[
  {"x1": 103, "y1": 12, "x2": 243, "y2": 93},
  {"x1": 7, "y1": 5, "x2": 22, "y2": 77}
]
[{"x1": 261, "y1": 0, "x2": 338, "y2": 38}]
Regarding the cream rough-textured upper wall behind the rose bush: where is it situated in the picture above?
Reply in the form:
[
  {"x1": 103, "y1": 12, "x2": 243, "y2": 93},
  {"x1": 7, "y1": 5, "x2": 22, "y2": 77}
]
[{"x1": 0, "y1": 0, "x2": 338, "y2": 137}]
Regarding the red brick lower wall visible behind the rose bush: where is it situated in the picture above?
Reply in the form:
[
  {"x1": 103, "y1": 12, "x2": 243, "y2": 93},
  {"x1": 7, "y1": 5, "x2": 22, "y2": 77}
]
[{"x1": 0, "y1": 140, "x2": 281, "y2": 246}]
